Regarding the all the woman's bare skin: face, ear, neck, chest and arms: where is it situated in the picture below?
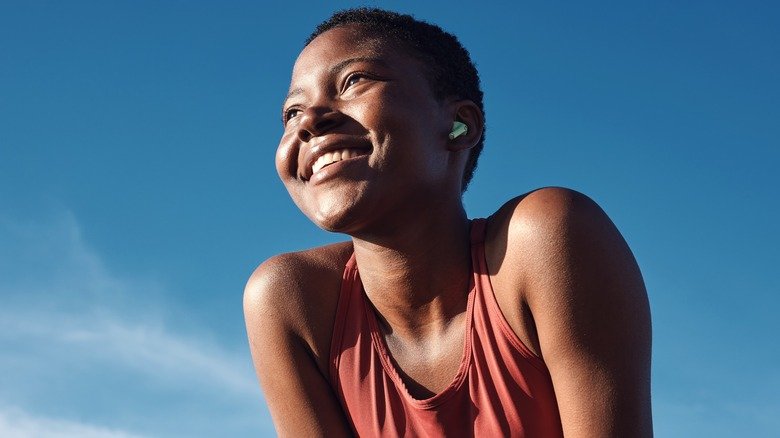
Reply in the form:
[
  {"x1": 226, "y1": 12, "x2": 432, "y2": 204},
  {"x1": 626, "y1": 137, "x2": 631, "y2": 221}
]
[{"x1": 244, "y1": 27, "x2": 652, "y2": 437}]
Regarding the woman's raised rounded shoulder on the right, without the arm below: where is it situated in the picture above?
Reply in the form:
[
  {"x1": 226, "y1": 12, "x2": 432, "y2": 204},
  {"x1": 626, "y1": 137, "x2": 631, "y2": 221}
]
[{"x1": 486, "y1": 187, "x2": 646, "y2": 318}]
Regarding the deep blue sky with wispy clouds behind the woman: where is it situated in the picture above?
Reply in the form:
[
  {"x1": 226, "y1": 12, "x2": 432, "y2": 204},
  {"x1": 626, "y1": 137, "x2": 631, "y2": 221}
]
[{"x1": 0, "y1": 1, "x2": 780, "y2": 437}]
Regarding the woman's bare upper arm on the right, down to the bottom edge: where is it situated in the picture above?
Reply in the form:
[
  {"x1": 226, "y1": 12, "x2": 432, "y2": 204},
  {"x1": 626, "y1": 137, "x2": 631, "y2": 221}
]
[{"x1": 510, "y1": 189, "x2": 652, "y2": 437}]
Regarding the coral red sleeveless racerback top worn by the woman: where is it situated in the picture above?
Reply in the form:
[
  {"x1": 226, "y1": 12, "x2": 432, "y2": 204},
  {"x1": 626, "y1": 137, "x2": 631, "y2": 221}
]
[{"x1": 329, "y1": 219, "x2": 563, "y2": 437}]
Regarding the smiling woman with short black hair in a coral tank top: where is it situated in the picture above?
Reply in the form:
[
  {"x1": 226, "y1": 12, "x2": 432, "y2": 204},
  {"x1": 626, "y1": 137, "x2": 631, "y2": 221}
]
[{"x1": 245, "y1": 9, "x2": 652, "y2": 437}]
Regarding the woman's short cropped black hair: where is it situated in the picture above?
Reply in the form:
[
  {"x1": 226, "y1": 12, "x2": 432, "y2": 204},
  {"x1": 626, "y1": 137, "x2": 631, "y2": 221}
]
[{"x1": 304, "y1": 8, "x2": 485, "y2": 192}]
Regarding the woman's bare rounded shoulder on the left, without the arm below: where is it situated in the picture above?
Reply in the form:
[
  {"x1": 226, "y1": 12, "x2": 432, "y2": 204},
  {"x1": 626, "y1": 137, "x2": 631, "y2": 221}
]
[{"x1": 244, "y1": 242, "x2": 352, "y2": 370}]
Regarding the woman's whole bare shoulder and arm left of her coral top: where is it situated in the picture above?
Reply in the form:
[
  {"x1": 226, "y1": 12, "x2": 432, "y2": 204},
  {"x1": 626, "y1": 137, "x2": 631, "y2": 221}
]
[{"x1": 244, "y1": 243, "x2": 352, "y2": 436}]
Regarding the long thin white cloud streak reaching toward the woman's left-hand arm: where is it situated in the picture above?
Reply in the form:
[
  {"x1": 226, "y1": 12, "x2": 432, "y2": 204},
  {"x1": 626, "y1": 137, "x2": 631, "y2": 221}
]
[{"x1": 0, "y1": 308, "x2": 258, "y2": 397}]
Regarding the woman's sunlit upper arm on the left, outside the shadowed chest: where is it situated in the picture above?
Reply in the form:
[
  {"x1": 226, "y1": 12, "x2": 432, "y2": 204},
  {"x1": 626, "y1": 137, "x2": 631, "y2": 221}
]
[{"x1": 244, "y1": 255, "x2": 350, "y2": 436}]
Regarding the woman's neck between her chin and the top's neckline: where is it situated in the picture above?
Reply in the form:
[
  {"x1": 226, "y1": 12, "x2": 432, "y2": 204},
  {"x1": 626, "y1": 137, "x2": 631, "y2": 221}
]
[{"x1": 352, "y1": 204, "x2": 471, "y2": 340}]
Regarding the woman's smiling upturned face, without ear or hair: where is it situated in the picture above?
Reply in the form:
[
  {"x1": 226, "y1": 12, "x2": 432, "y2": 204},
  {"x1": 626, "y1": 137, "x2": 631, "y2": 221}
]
[{"x1": 276, "y1": 27, "x2": 460, "y2": 234}]
